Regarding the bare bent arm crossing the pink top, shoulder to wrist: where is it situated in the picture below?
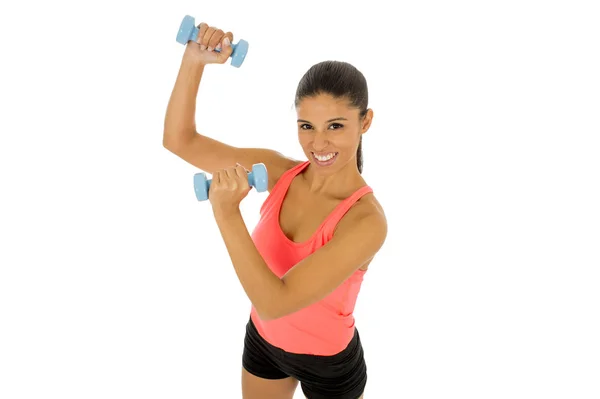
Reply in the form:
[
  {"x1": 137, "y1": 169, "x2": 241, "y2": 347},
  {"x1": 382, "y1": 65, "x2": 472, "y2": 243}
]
[{"x1": 217, "y1": 200, "x2": 387, "y2": 320}]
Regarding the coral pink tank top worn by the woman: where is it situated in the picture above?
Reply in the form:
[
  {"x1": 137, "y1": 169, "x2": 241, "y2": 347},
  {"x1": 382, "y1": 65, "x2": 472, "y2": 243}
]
[{"x1": 250, "y1": 161, "x2": 373, "y2": 356}]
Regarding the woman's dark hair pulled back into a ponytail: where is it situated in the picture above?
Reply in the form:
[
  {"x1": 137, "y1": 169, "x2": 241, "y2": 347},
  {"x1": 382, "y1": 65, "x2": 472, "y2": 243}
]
[{"x1": 294, "y1": 61, "x2": 369, "y2": 173}]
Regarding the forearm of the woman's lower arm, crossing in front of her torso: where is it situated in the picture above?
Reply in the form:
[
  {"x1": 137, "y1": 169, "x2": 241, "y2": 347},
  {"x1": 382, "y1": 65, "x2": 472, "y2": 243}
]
[{"x1": 216, "y1": 212, "x2": 284, "y2": 319}]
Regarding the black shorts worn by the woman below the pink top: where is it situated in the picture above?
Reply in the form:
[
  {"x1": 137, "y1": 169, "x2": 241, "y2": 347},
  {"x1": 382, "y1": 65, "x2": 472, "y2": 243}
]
[{"x1": 242, "y1": 319, "x2": 367, "y2": 399}]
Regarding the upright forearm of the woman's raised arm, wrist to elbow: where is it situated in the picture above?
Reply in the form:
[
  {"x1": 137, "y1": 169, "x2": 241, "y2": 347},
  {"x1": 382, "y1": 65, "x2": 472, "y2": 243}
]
[{"x1": 163, "y1": 52, "x2": 205, "y2": 146}]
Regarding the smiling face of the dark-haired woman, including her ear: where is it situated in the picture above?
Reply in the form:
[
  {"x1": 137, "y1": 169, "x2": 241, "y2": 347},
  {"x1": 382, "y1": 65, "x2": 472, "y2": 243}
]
[{"x1": 296, "y1": 94, "x2": 373, "y2": 174}]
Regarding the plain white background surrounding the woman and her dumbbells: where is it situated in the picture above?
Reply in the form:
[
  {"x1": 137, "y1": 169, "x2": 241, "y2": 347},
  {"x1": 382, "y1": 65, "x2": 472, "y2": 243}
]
[{"x1": 0, "y1": 0, "x2": 600, "y2": 399}]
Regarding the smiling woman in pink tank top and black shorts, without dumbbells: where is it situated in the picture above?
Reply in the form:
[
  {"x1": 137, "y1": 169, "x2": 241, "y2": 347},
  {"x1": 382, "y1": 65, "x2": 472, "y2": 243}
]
[{"x1": 163, "y1": 23, "x2": 387, "y2": 399}]
